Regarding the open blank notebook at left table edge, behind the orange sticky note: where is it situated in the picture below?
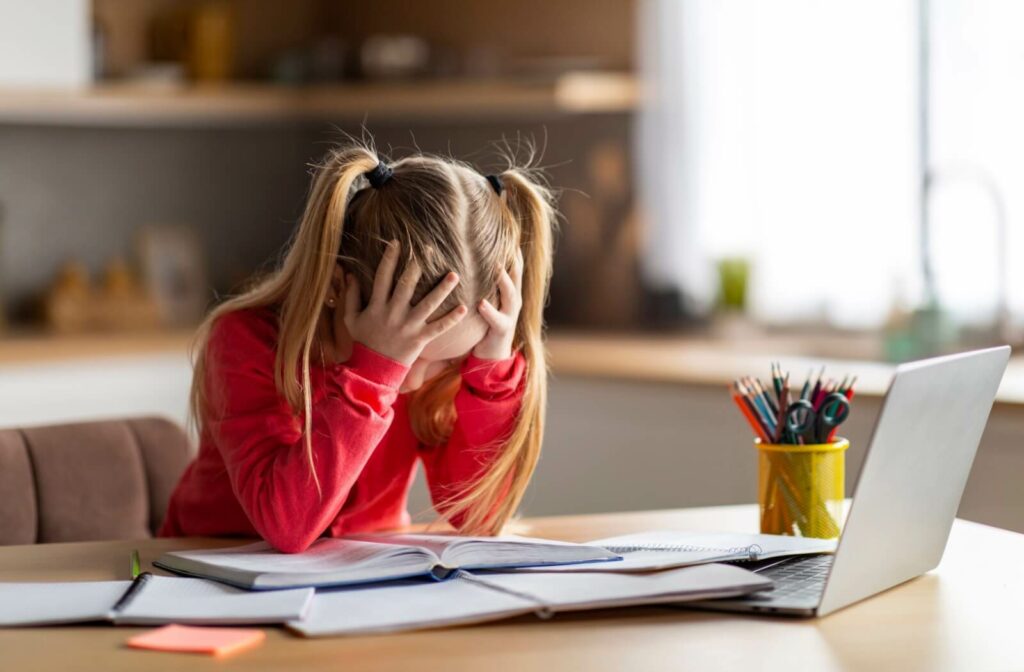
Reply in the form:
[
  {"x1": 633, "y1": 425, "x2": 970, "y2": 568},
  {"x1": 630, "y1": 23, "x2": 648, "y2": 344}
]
[{"x1": 0, "y1": 575, "x2": 313, "y2": 627}]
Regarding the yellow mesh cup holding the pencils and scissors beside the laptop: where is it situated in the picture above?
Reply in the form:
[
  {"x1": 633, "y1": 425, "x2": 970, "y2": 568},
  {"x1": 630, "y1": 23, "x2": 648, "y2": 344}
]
[{"x1": 754, "y1": 438, "x2": 850, "y2": 539}]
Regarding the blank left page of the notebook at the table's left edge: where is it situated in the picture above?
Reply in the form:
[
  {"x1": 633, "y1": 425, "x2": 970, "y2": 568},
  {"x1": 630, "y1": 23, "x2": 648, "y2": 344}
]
[{"x1": 0, "y1": 581, "x2": 131, "y2": 627}]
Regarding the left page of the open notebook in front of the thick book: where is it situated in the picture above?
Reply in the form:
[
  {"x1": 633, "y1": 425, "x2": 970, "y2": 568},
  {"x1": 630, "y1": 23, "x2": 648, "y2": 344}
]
[{"x1": 288, "y1": 574, "x2": 538, "y2": 637}]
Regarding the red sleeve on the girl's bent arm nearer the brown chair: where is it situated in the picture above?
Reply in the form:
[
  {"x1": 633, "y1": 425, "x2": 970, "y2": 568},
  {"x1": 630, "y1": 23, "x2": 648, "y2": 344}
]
[{"x1": 205, "y1": 314, "x2": 408, "y2": 553}]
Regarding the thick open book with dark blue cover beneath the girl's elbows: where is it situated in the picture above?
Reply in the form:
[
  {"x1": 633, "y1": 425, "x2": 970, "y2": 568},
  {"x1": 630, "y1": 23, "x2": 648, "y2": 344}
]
[{"x1": 154, "y1": 535, "x2": 618, "y2": 590}]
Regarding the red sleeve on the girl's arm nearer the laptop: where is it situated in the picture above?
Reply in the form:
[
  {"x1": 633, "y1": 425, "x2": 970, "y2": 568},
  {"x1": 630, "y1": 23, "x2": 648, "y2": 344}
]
[{"x1": 423, "y1": 352, "x2": 526, "y2": 528}]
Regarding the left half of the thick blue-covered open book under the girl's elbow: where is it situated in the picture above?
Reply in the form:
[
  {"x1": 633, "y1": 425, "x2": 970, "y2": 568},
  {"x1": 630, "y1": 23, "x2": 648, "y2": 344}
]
[{"x1": 156, "y1": 539, "x2": 436, "y2": 588}]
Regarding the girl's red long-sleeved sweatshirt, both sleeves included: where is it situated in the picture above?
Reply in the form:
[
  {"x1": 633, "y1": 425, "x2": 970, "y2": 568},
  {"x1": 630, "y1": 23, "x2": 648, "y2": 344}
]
[{"x1": 160, "y1": 309, "x2": 525, "y2": 552}]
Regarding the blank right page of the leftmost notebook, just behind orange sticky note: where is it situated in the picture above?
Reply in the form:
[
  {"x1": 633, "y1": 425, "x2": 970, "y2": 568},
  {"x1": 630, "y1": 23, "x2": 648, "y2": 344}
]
[{"x1": 114, "y1": 576, "x2": 313, "y2": 625}]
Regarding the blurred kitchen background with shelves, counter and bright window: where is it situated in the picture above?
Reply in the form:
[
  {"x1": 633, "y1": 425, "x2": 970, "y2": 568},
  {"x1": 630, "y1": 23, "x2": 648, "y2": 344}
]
[{"x1": 0, "y1": 0, "x2": 1024, "y2": 531}]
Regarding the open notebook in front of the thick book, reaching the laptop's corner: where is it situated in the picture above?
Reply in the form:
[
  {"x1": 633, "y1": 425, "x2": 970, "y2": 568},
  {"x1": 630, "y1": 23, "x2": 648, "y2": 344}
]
[{"x1": 288, "y1": 564, "x2": 771, "y2": 637}]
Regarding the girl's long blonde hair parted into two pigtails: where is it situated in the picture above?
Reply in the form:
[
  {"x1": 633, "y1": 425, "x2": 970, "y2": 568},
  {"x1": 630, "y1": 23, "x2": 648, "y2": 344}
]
[{"x1": 189, "y1": 140, "x2": 556, "y2": 535}]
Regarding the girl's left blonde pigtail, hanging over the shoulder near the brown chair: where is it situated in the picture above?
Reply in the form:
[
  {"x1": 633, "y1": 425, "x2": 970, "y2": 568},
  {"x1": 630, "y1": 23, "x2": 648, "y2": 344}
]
[{"x1": 189, "y1": 146, "x2": 380, "y2": 490}]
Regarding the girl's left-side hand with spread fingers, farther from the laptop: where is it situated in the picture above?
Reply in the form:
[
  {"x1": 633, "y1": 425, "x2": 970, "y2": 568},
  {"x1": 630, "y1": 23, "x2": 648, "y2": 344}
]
[{"x1": 346, "y1": 241, "x2": 467, "y2": 366}]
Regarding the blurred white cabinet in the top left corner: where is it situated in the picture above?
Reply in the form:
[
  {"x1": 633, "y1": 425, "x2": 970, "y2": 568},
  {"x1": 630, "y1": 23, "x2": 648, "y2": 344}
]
[{"x1": 0, "y1": 0, "x2": 92, "y2": 87}]
